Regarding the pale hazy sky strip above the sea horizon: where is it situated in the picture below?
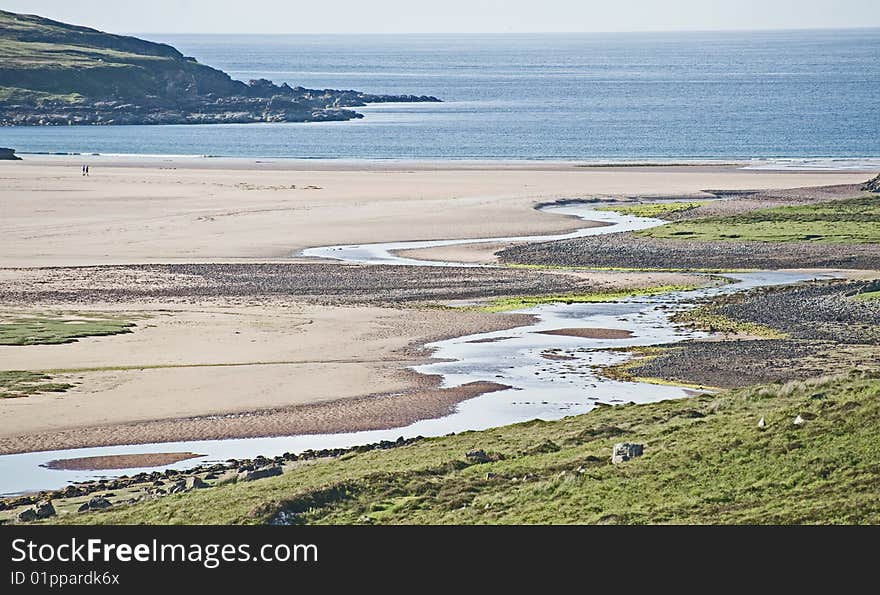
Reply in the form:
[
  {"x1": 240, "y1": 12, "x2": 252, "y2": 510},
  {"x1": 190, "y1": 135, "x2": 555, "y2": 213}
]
[{"x1": 0, "y1": 0, "x2": 880, "y2": 33}]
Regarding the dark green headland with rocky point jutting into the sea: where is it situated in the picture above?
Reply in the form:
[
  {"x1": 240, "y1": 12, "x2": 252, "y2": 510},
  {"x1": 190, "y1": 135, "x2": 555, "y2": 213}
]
[{"x1": 0, "y1": 11, "x2": 440, "y2": 126}]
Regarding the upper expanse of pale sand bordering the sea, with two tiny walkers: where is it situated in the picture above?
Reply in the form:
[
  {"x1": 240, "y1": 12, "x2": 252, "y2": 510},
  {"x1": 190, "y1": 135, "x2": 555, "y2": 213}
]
[{"x1": 0, "y1": 157, "x2": 865, "y2": 267}]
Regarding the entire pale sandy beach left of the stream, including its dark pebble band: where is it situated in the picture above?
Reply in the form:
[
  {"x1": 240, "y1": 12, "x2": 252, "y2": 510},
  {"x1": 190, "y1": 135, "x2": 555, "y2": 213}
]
[{"x1": 0, "y1": 157, "x2": 866, "y2": 453}]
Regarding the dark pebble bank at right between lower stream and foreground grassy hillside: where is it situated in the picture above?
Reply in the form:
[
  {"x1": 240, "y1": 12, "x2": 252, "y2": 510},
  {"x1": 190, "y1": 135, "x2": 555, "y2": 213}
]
[{"x1": 611, "y1": 280, "x2": 880, "y2": 388}]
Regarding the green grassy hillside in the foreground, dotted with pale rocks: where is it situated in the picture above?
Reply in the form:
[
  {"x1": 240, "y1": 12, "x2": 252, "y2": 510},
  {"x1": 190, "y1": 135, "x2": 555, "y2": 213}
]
[{"x1": 56, "y1": 375, "x2": 880, "y2": 524}]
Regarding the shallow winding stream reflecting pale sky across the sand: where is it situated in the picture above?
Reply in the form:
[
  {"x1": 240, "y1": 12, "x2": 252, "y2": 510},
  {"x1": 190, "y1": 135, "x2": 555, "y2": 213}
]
[{"x1": 0, "y1": 204, "x2": 821, "y2": 494}]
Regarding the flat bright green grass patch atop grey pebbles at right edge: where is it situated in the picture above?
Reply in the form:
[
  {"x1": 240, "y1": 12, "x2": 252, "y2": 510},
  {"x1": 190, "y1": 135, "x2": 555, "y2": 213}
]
[{"x1": 638, "y1": 196, "x2": 880, "y2": 244}]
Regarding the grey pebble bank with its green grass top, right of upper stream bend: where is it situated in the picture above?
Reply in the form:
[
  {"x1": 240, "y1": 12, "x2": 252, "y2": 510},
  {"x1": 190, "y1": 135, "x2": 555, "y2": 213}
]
[{"x1": 498, "y1": 191, "x2": 880, "y2": 271}]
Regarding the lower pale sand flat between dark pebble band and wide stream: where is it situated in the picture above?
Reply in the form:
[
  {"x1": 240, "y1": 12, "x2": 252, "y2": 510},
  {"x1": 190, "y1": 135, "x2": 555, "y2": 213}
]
[{"x1": 0, "y1": 304, "x2": 530, "y2": 453}]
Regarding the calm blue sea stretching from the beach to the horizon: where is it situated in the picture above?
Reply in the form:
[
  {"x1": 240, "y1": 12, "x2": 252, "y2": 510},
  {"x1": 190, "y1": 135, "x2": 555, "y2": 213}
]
[{"x1": 0, "y1": 29, "x2": 880, "y2": 160}]
